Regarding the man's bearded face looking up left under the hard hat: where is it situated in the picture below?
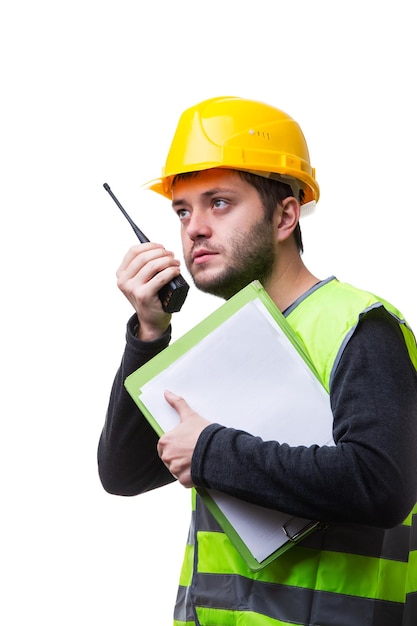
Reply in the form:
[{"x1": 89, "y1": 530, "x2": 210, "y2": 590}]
[{"x1": 172, "y1": 169, "x2": 276, "y2": 299}]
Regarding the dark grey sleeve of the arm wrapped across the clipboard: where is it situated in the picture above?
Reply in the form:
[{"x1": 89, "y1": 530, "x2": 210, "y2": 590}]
[{"x1": 191, "y1": 307, "x2": 417, "y2": 528}]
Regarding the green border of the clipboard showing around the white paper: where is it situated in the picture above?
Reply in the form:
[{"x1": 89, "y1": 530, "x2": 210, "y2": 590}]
[{"x1": 124, "y1": 280, "x2": 328, "y2": 571}]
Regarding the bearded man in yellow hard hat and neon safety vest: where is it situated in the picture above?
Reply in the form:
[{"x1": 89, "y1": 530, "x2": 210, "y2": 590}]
[{"x1": 99, "y1": 98, "x2": 417, "y2": 626}]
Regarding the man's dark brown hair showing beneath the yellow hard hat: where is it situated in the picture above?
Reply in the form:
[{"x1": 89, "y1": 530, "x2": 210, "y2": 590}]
[{"x1": 172, "y1": 170, "x2": 304, "y2": 254}]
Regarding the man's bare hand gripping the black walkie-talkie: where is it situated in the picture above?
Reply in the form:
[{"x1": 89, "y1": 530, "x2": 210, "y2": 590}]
[{"x1": 116, "y1": 242, "x2": 180, "y2": 341}]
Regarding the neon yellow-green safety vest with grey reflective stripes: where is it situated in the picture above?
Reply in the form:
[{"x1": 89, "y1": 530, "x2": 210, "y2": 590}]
[{"x1": 174, "y1": 278, "x2": 417, "y2": 626}]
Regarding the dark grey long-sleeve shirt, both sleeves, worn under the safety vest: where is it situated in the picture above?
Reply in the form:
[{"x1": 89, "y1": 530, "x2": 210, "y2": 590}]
[{"x1": 98, "y1": 308, "x2": 417, "y2": 528}]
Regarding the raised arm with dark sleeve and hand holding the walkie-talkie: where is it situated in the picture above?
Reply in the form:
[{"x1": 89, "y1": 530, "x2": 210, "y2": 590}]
[{"x1": 98, "y1": 243, "x2": 184, "y2": 495}]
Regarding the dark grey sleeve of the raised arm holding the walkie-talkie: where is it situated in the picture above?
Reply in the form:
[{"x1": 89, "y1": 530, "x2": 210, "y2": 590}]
[{"x1": 98, "y1": 315, "x2": 175, "y2": 496}]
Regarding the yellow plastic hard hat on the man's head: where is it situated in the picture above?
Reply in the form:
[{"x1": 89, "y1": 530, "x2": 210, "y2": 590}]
[{"x1": 145, "y1": 97, "x2": 320, "y2": 203}]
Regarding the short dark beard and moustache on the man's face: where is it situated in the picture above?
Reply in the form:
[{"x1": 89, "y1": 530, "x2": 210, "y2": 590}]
[{"x1": 186, "y1": 218, "x2": 275, "y2": 300}]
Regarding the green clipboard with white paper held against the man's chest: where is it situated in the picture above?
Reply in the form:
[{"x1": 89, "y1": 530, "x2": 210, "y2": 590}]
[{"x1": 125, "y1": 281, "x2": 334, "y2": 571}]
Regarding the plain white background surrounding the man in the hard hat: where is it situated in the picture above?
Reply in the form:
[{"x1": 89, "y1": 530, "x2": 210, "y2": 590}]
[{"x1": 0, "y1": 0, "x2": 417, "y2": 626}]
